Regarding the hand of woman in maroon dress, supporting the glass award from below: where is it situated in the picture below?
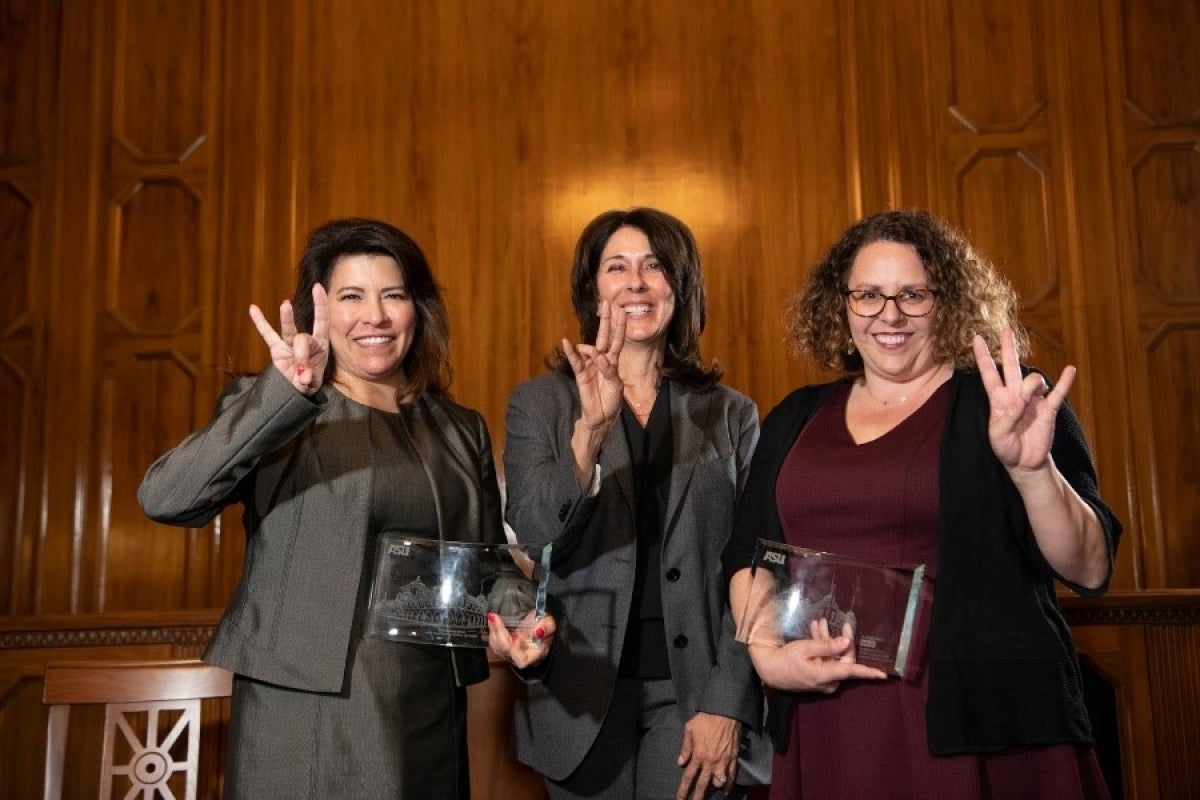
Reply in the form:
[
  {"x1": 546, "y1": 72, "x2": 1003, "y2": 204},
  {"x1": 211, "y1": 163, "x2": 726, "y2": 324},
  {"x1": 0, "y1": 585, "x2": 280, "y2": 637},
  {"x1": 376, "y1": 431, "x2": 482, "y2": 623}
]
[{"x1": 750, "y1": 620, "x2": 888, "y2": 694}]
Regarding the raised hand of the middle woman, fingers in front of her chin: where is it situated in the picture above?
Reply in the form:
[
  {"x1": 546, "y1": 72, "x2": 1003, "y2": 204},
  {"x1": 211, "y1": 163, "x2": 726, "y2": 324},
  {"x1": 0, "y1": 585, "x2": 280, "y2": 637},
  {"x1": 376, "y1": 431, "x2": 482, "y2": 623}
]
[{"x1": 563, "y1": 300, "x2": 625, "y2": 432}]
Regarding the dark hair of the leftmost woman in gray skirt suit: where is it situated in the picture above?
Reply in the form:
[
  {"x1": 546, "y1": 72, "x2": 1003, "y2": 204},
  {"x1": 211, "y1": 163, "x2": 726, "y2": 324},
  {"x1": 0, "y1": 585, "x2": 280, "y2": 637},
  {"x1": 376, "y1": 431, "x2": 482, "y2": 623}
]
[{"x1": 292, "y1": 217, "x2": 454, "y2": 401}]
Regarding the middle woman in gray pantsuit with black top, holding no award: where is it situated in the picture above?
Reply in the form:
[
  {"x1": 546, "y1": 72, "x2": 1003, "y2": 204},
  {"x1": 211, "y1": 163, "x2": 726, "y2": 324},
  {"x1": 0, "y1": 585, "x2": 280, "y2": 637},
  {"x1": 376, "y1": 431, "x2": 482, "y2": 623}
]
[{"x1": 493, "y1": 209, "x2": 768, "y2": 800}]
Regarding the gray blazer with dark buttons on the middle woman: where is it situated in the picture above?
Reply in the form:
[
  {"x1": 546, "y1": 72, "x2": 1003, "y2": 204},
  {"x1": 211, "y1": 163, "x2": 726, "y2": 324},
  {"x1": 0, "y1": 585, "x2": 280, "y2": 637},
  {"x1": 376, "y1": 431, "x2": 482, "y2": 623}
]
[{"x1": 504, "y1": 372, "x2": 770, "y2": 783}]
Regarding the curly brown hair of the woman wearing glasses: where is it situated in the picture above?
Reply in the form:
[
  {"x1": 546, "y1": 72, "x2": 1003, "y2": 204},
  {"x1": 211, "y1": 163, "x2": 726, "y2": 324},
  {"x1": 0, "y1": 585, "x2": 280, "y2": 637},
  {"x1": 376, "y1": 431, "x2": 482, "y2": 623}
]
[{"x1": 786, "y1": 209, "x2": 1028, "y2": 375}]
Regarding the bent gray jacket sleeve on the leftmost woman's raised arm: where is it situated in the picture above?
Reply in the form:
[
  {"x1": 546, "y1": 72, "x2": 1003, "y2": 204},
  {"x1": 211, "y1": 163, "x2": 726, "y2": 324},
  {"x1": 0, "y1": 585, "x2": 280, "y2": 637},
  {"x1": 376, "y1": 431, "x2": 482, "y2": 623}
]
[{"x1": 138, "y1": 367, "x2": 323, "y2": 528}]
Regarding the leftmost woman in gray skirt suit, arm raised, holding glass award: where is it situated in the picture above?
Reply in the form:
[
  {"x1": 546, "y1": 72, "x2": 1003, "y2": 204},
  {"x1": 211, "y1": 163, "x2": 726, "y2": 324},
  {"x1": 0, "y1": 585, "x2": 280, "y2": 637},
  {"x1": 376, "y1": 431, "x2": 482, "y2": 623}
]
[{"x1": 138, "y1": 219, "x2": 503, "y2": 800}]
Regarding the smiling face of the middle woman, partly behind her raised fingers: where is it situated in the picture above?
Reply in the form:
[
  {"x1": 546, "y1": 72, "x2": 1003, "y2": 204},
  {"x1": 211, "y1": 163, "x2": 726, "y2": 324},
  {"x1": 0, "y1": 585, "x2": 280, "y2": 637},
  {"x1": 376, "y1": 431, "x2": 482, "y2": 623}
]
[{"x1": 596, "y1": 227, "x2": 676, "y2": 348}]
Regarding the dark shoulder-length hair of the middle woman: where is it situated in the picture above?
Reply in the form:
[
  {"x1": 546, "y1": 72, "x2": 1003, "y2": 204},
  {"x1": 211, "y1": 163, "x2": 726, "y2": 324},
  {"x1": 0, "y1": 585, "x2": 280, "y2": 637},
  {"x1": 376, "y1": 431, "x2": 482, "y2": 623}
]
[{"x1": 550, "y1": 207, "x2": 721, "y2": 389}]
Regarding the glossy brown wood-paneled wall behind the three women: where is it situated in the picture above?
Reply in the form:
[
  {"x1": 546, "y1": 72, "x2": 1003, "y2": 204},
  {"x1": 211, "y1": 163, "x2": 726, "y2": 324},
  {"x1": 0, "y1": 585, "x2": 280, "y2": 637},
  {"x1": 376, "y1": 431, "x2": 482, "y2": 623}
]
[{"x1": 0, "y1": 0, "x2": 1200, "y2": 796}]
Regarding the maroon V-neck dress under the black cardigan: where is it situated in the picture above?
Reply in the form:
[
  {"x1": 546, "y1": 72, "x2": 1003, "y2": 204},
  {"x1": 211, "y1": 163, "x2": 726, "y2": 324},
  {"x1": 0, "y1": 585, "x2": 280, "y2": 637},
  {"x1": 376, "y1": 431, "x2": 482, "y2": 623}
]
[{"x1": 770, "y1": 383, "x2": 1108, "y2": 800}]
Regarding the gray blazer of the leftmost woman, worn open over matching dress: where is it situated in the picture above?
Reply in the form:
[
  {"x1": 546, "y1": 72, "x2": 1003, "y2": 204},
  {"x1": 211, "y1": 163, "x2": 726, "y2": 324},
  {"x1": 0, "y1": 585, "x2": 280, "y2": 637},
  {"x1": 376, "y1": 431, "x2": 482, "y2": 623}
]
[{"x1": 138, "y1": 367, "x2": 504, "y2": 692}]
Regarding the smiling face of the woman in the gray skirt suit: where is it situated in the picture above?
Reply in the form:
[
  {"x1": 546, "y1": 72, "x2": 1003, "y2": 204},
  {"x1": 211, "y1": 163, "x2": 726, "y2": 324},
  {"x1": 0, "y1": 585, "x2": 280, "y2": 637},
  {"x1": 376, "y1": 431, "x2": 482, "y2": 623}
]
[{"x1": 328, "y1": 253, "x2": 416, "y2": 398}]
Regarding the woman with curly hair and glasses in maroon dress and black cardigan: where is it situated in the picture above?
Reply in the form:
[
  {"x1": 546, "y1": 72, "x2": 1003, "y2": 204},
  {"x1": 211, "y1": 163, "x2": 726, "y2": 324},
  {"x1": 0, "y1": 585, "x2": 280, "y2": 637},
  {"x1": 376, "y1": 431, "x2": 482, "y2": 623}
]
[{"x1": 722, "y1": 210, "x2": 1121, "y2": 798}]
